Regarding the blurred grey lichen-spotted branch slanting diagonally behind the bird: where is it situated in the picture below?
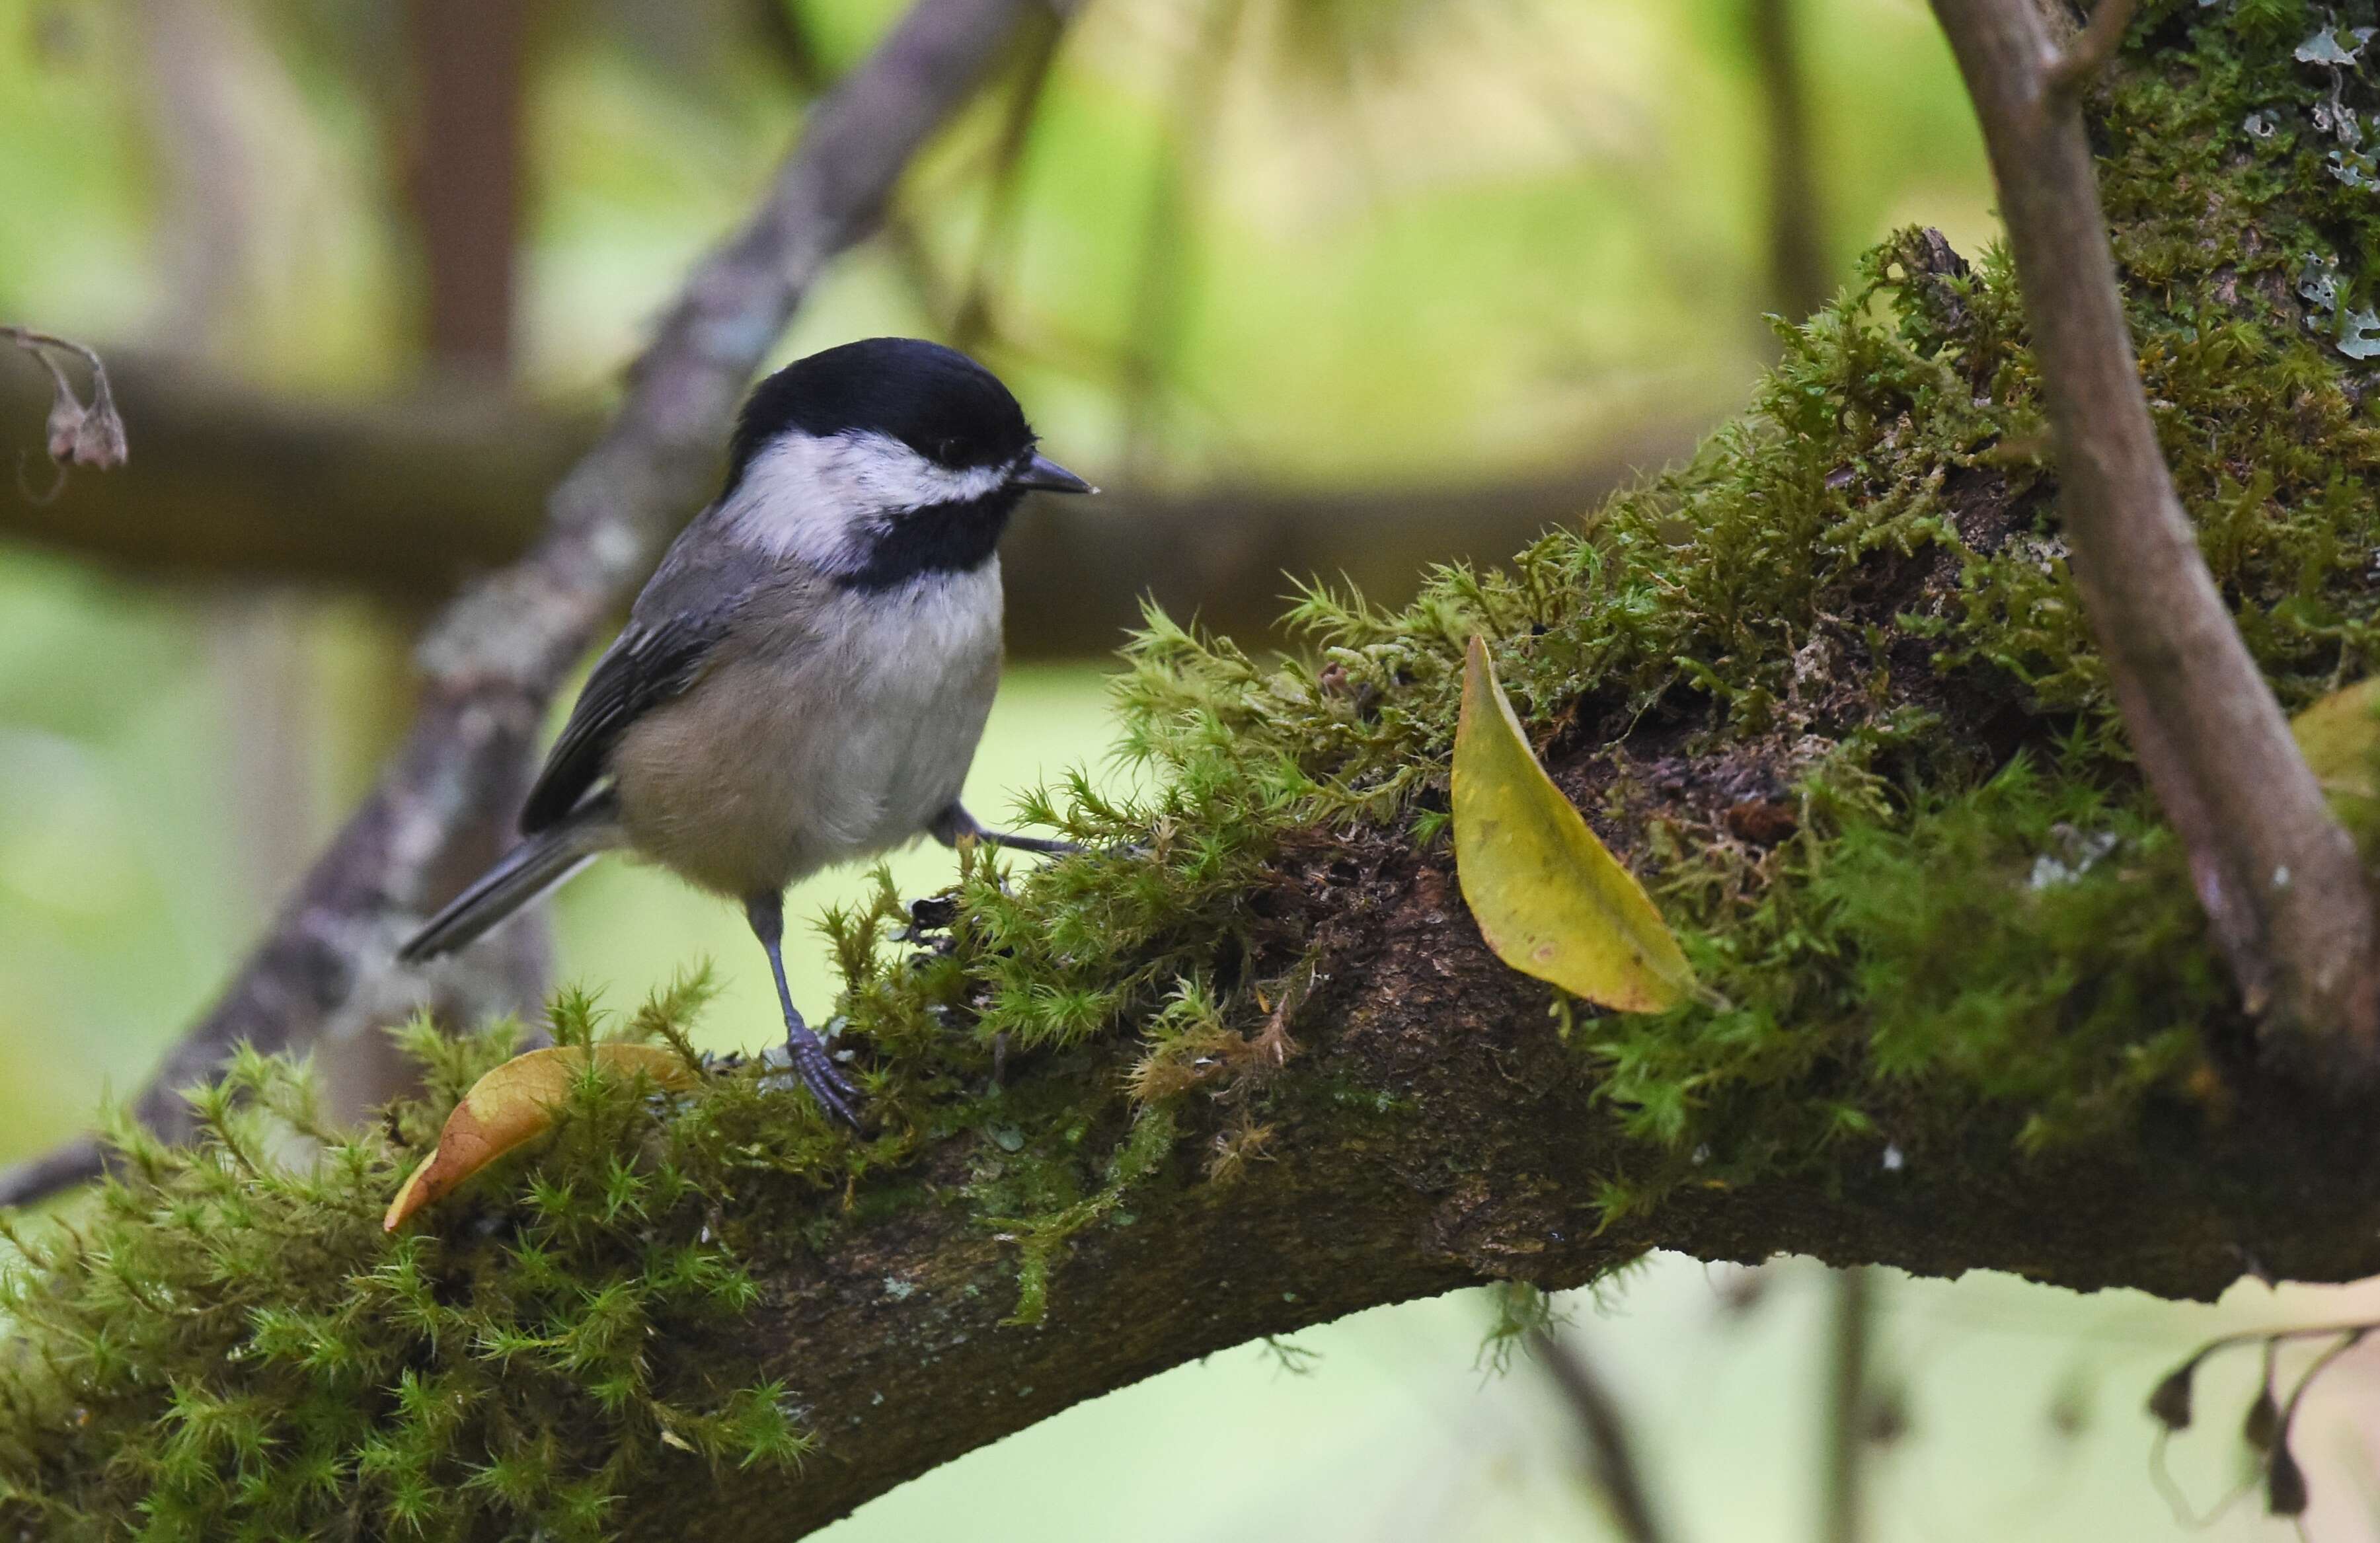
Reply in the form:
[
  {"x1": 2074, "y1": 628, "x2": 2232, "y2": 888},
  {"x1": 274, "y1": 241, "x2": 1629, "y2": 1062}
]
[{"x1": 0, "y1": 0, "x2": 1028, "y2": 1203}]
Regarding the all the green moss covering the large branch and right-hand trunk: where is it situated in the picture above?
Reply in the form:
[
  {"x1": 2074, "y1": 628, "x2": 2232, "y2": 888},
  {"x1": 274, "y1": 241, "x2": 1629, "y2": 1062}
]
[{"x1": 0, "y1": 0, "x2": 2380, "y2": 1538}]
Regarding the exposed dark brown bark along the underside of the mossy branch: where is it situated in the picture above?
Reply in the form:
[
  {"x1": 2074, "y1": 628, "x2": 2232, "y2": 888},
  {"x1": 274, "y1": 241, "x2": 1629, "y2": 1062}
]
[{"x1": 438, "y1": 852, "x2": 2380, "y2": 1538}]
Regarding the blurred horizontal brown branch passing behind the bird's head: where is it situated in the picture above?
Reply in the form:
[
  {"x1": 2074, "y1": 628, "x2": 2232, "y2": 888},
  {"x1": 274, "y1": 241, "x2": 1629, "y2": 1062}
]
[{"x1": 0, "y1": 355, "x2": 1707, "y2": 659}]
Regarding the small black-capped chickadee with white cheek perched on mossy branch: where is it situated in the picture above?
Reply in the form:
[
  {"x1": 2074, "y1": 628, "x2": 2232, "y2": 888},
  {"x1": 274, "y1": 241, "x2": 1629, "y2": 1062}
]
[{"x1": 397, "y1": 338, "x2": 1093, "y2": 1124}]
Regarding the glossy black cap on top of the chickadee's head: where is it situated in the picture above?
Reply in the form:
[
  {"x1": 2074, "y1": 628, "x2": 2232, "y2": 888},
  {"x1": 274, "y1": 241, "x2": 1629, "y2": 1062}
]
[{"x1": 728, "y1": 338, "x2": 1033, "y2": 486}]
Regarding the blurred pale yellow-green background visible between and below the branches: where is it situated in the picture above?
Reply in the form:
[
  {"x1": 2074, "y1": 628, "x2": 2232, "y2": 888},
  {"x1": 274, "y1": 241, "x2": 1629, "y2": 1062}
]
[{"x1": 0, "y1": 0, "x2": 2380, "y2": 1543}]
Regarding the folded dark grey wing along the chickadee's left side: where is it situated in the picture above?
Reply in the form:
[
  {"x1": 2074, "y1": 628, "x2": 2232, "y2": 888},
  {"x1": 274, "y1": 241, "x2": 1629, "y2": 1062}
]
[{"x1": 521, "y1": 517, "x2": 771, "y2": 836}]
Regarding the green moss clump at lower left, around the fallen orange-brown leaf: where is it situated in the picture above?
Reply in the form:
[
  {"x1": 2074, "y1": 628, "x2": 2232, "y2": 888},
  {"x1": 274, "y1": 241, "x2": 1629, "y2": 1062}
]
[{"x1": 0, "y1": 1024, "x2": 807, "y2": 1538}]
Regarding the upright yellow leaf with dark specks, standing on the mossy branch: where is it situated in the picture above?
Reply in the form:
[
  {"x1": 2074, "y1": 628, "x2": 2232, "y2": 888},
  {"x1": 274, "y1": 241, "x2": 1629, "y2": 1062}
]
[{"x1": 1454, "y1": 638, "x2": 1695, "y2": 1012}]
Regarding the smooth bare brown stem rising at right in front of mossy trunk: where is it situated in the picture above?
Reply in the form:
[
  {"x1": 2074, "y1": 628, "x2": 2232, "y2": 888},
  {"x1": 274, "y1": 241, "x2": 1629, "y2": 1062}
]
[{"x1": 1935, "y1": 0, "x2": 2380, "y2": 1086}]
